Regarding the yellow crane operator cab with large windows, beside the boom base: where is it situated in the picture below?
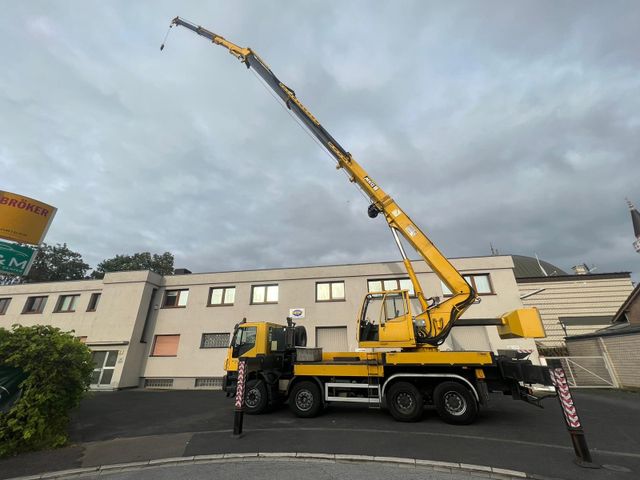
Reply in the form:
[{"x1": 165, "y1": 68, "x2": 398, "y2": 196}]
[{"x1": 358, "y1": 290, "x2": 425, "y2": 348}]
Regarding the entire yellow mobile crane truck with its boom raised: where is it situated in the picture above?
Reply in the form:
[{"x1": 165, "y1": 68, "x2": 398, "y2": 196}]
[{"x1": 169, "y1": 17, "x2": 552, "y2": 424}]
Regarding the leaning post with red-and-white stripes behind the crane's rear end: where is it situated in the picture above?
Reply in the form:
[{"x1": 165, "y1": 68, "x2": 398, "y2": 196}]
[{"x1": 549, "y1": 360, "x2": 600, "y2": 468}]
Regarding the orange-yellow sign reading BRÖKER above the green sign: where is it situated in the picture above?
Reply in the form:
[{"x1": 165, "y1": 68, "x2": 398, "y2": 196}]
[{"x1": 0, "y1": 190, "x2": 56, "y2": 245}]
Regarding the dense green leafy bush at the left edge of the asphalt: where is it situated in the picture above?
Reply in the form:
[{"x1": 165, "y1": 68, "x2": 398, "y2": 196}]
[{"x1": 0, "y1": 325, "x2": 93, "y2": 457}]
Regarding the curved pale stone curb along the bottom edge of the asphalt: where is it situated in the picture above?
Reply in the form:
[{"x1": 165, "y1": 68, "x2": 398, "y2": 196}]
[{"x1": 3, "y1": 452, "x2": 551, "y2": 480}]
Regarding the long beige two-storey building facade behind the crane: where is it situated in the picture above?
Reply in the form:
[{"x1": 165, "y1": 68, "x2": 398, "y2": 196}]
[{"x1": 0, "y1": 256, "x2": 537, "y2": 389}]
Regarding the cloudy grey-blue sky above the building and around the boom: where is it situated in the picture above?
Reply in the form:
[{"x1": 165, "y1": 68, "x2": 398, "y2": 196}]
[{"x1": 0, "y1": 0, "x2": 640, "y2": 277}]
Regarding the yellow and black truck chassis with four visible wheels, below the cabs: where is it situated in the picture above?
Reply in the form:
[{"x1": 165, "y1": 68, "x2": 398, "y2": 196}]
[{"x1": 224, "y1": 348, "x2": 552, "y2": 425}]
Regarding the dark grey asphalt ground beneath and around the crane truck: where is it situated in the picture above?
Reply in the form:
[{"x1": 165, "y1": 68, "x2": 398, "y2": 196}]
[{"x1": 0, "y1": 390, "x2": 640, "y2": 480}]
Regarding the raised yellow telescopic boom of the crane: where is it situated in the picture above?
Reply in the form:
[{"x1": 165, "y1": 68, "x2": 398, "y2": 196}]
[{"x1": 171, "y1": 17, "x2": 477, "y2": 345}]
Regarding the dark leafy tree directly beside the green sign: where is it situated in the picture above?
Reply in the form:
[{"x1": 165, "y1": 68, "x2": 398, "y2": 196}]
[{"x1": 25, "y1": 243, "x2": 89, "y2": 282}]
